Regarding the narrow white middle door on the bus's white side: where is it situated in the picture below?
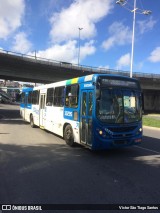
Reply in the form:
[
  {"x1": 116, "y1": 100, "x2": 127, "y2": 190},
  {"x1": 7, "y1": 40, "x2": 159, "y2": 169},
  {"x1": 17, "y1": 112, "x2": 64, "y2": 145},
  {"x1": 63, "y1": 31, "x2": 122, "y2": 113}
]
[{"x1": 39, "y1": 94, "x2": 46, "y2": 127}]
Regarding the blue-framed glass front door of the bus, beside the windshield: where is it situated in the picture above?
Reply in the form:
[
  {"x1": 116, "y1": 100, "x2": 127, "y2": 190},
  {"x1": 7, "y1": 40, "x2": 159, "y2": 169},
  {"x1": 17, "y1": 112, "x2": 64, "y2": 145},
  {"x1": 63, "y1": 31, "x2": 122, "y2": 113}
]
[{"x1": 80, "y1": 90, "x2": 93, "y2": 146}]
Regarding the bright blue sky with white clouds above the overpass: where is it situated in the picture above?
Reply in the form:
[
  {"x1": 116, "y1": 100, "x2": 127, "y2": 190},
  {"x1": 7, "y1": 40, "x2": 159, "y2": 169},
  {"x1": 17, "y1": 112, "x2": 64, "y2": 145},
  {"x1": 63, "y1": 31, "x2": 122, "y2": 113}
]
[{"x1": 0, "y1": 0, "x2": 160, "y2": 74}]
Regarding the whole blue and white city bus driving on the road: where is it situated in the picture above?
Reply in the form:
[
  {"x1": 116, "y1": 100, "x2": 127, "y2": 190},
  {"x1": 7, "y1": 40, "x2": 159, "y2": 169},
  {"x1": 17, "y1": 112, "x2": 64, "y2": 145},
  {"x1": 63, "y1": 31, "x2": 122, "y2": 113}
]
[{"x1": 20, "y1": 74, "x2": 142, "y2": 150}]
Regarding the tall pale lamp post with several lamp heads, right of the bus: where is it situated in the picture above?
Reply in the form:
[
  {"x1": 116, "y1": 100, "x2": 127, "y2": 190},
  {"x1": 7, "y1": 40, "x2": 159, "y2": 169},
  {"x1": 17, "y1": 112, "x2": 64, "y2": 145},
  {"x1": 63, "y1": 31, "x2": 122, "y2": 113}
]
[{"x1": 116, "y1": 0, "x2": 152, "y2": 78}]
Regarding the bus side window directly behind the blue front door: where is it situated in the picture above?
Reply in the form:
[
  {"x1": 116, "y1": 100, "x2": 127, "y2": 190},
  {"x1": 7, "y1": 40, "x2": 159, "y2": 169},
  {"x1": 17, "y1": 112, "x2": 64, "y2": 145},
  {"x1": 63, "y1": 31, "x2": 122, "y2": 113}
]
[{"x1": 65, "y1": 84, "x2": 79, "y2": 108}]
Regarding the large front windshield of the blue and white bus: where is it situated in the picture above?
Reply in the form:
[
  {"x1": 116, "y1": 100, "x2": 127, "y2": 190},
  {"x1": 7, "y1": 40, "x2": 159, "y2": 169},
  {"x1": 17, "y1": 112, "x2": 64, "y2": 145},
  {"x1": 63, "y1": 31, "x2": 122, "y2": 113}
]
[{"x1": 96, "y1": 88, "x2": 142, "y2": 124}]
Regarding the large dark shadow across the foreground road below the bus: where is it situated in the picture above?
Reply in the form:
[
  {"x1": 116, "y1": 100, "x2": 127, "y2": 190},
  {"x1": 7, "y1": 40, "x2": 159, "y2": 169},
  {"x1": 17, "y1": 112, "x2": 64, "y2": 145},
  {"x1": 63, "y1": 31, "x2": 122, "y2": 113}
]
[{"x1": 0, "y1": 137, "x2": 160, "y2": 204}]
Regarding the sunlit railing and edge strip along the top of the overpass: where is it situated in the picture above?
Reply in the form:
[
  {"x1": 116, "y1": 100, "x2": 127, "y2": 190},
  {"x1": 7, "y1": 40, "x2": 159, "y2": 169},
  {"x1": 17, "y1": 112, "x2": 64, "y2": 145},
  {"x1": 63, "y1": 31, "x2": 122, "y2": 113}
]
[{"x1": 0, "y1": 49, "x2": 160, "y2": 79}]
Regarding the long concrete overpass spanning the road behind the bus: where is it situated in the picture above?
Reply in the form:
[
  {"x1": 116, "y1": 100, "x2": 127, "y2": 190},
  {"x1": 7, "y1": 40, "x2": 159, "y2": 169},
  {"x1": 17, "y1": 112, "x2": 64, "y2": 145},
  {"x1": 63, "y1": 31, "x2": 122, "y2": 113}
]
[{"x1": 0, "y1": 51, "x2": 160, "y2": 112}]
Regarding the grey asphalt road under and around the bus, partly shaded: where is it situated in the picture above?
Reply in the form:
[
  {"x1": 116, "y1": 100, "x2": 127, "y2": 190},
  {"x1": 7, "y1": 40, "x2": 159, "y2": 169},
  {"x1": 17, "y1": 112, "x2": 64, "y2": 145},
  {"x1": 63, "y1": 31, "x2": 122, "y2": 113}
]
[{"x1": 0, "y1": 104, "x2": 160, "y2": 212}]
